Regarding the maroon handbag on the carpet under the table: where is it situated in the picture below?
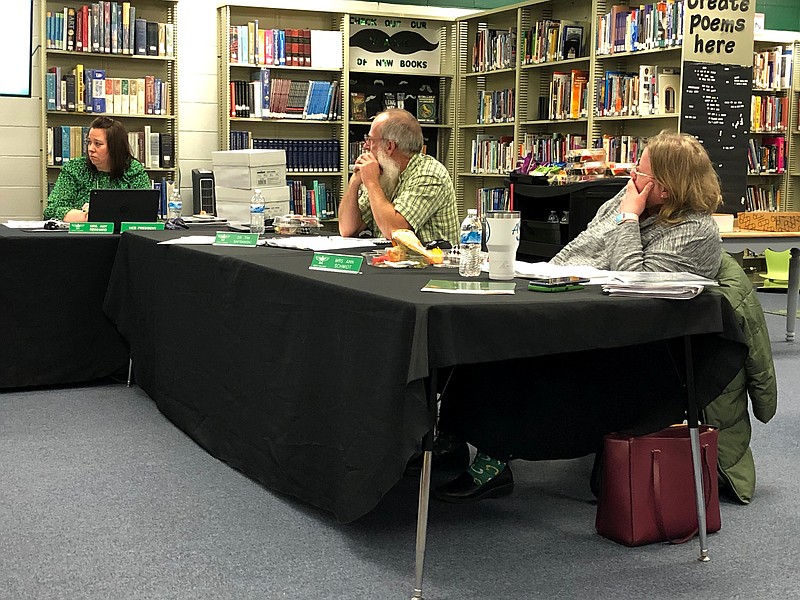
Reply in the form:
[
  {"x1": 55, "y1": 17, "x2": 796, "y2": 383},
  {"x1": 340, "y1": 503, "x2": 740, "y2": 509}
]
[{"x1": 595, "y1": 425, "x2": 722, "y2": 546}]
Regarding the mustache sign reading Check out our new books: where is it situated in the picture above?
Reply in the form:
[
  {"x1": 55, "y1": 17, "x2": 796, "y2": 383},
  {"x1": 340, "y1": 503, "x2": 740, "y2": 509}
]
[{"x1": 349, "y1": 15, "x2": 441, "y2": 75}]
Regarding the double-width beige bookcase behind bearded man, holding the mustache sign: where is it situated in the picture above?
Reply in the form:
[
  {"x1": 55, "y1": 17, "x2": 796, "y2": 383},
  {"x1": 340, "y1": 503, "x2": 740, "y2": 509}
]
[{"x1": 217, "y1": 3, "x2": 456, "y2": 221}]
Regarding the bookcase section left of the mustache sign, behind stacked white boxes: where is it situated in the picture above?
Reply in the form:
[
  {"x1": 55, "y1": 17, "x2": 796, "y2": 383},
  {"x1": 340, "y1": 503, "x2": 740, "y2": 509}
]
[{"x1": 217, "y1": 5, "x2": 347, "y2": 223}]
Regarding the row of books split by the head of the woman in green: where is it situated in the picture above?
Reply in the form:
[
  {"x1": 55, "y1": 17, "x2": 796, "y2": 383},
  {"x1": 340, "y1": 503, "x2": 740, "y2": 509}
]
[{"x1": 47, "y1": 125, "x2": 175, "y2": 169}]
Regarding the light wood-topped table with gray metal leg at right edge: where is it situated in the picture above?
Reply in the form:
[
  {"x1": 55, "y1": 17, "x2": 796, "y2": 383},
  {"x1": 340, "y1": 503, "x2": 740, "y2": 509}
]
[{"x1": 722, "y1": 229, "x2": 800, "y2": 342}]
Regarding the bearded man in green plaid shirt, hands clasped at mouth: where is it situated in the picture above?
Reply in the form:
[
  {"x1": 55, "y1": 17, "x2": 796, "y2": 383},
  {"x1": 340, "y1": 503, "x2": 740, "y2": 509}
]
[{"x1": 339, "y1": 108, "x2": 458, "y2": 244}]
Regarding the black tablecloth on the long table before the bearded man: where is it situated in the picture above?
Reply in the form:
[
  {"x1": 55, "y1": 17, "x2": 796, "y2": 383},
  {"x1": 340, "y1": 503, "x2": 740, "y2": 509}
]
[{"x1": 105, "y1": 232, "x2": 742, "y2": 521}]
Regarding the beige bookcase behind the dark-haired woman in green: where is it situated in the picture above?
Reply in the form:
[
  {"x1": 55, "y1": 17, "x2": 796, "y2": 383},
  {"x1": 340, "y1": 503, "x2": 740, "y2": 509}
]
[{"x1": 40, "y1": 0, "x2": 180, "y2": 208}]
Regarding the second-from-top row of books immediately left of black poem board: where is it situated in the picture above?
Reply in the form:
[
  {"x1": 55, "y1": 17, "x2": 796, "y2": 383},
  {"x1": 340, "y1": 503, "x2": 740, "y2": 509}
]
[{"x1": 595, "y1": 65, "x2": 680, "y2": 117}]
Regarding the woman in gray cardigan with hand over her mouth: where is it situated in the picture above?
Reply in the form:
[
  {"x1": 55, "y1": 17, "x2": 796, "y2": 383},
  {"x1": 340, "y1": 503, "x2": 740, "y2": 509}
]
[{"x1": 434, "y1": 132, "x2": 721, "y2": 502}]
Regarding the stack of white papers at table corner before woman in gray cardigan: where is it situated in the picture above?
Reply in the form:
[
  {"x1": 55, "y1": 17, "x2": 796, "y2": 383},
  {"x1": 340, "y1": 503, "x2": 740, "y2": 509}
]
[{"x1": 603, "y1": 271, "x2": 719, "y2": 300}]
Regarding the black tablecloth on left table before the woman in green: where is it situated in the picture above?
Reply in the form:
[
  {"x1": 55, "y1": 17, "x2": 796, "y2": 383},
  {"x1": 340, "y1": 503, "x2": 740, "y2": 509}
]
[{"x1": 0, "y1": 226, "x2": 128, "y2": 388}]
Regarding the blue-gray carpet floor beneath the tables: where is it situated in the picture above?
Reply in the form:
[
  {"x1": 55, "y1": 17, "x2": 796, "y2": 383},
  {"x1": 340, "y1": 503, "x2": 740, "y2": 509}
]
[{"x1": 0, "y1": 294, "x2": 800, "y2": 600}]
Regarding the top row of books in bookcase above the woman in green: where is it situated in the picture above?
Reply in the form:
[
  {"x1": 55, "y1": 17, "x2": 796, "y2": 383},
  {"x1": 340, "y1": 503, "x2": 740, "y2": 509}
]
[{"x1": 45, "y1": 1, "x2": 175, "y2": 56}]
